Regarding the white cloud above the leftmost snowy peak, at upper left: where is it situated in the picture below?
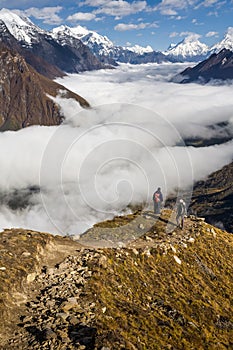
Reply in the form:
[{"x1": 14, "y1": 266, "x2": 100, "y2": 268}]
[{"x1": 18, "y1": 6, "x2": 62, "y2": 24}]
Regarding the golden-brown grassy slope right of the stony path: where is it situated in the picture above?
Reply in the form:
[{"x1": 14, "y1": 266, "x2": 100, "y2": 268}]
[{"x1": 84, "y1": 211, "x2": 233, "y2": 350}]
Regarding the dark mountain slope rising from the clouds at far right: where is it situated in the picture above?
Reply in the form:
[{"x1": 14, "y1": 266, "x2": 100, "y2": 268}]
[{"x1": 176, "y1": 49, "x2": 233, "y2": 83}]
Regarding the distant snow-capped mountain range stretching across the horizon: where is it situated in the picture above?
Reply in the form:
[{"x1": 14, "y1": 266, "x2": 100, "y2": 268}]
[{"x1": 0, "y1": 9, "x2": 233, "y2": 68}]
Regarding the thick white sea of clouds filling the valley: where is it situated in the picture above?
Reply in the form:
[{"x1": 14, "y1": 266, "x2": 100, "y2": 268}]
[{"x1": 0, "y1": 64, "x2": 233, "y2": 235}]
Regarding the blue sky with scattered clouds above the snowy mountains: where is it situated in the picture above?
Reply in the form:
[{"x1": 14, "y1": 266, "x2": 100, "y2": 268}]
[{"x1": 0, "y1": 0, "x2": 233, "y2": 50}]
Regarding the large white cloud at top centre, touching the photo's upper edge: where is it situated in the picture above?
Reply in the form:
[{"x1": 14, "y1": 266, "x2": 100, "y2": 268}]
[{"x1": 82, "y1": 0, "x2": 147, "y2": 19}]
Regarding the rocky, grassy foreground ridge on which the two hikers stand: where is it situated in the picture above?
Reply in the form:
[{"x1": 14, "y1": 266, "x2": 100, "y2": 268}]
[{"x1": 0, "y1": 209, "x2": 233, "y2": 350}]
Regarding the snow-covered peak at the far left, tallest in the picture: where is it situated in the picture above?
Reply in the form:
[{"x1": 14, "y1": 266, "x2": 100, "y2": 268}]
[{"x1": 0, "y1": 8, "x2": 45, "y2": 45}]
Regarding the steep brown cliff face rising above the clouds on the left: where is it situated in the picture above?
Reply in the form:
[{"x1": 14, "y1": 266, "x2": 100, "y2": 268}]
[{"x1": 0, "y1": 44, "x2": 88, "y2": 131}]
